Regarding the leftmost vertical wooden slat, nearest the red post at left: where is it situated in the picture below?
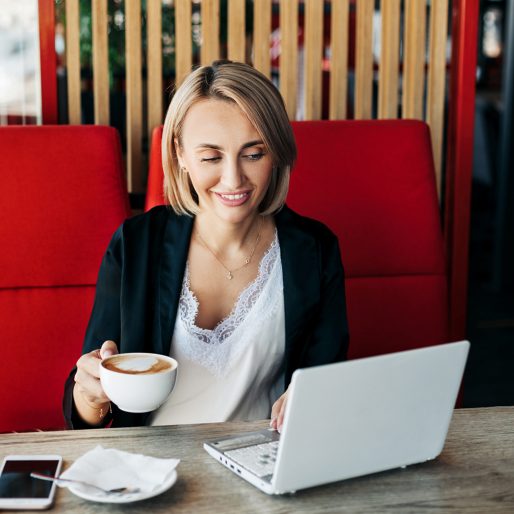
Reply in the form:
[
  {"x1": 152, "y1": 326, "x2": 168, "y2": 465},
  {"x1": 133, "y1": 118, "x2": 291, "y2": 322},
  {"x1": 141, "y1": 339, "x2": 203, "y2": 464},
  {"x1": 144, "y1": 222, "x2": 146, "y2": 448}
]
[{"x1": 66, "y1": 0, "x2": 82, "y2": 125}]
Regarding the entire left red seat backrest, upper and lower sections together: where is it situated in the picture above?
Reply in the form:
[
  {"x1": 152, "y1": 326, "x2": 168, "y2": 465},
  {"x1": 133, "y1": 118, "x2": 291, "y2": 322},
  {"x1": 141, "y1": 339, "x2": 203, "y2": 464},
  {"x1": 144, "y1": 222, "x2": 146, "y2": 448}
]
[{"x1": 0, "y1": 126, "x2": 130, "y2": 432}]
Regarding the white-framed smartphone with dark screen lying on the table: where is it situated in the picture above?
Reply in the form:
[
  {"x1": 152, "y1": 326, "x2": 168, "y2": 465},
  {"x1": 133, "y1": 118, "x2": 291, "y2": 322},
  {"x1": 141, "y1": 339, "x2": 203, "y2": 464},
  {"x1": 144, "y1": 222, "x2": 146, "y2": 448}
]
[{"x1": 0, "y1": 455, "x2": 62, "y2": 510}]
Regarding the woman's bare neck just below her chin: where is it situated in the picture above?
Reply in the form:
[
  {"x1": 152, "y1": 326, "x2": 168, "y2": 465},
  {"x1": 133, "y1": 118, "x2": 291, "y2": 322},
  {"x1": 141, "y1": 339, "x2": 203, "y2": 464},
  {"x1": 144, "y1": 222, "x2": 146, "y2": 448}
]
[{"x1": 194, "y1": 213, "x2": 262, "y2": 254}]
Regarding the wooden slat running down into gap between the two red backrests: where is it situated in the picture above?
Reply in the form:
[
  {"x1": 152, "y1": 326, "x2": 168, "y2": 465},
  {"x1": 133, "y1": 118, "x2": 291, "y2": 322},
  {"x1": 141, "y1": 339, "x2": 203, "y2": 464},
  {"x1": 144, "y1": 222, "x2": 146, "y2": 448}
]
[{"x1": 125, "y1": 0, "x2": 144, "y2": 192}]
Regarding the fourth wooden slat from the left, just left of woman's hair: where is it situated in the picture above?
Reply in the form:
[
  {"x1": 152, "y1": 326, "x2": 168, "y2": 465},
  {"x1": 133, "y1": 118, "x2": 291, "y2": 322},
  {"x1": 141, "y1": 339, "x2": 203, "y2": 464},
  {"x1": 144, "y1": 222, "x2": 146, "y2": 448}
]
[{"x1": 146, "y1": 0, "x2": 162, "y2": 141}]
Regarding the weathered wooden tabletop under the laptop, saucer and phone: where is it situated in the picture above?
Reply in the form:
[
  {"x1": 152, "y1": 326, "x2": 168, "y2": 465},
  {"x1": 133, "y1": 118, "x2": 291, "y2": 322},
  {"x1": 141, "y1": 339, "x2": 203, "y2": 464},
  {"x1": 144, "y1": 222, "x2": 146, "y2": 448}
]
[{"x1": 0, "y1": 407, "x2": 514, "y2": 514}]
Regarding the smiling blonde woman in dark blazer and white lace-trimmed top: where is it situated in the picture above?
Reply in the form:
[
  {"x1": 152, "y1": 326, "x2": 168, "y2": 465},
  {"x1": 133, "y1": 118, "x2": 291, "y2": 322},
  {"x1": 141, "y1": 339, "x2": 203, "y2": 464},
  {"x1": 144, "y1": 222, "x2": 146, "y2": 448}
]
[{"x1": 64, "y1": 61, "x2": 348, "y2": 429}]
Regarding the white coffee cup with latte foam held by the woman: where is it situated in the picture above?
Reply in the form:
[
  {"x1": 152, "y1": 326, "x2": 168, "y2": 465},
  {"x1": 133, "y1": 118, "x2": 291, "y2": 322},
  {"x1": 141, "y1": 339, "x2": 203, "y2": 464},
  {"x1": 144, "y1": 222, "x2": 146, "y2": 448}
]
[{"x1": 100, "y1": 353, "x2": 178, "y2": 413}]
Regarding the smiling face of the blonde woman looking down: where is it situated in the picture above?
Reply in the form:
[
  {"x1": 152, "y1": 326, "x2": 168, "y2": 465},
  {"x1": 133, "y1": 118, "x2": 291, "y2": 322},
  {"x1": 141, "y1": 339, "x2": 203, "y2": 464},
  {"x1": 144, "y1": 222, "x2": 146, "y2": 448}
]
[{"x1": 175, "y1": 99, "x2": 272, "y2": 223}]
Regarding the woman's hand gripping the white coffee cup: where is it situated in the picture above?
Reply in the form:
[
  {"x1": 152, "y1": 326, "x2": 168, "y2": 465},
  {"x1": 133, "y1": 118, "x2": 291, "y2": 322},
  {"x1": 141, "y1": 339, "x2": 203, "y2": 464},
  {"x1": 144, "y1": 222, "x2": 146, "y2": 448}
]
[{"x1": 73, "y1": 341, "x2": 118, "y2": 425}]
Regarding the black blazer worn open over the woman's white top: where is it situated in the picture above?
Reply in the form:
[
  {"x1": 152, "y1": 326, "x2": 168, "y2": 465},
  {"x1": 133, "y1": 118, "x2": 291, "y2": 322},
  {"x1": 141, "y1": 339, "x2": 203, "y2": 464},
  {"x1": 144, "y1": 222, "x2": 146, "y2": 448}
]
[{"x1": 63, "y1": 206, "x2": 348, "y2": 428}]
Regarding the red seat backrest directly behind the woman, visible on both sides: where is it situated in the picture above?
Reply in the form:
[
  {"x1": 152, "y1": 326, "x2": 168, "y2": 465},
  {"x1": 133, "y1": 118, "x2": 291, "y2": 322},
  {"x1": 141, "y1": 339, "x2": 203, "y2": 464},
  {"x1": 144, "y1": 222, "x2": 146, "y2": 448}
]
[{"x1": 147, "y1": 120, "x2": 448, "y2": 358}]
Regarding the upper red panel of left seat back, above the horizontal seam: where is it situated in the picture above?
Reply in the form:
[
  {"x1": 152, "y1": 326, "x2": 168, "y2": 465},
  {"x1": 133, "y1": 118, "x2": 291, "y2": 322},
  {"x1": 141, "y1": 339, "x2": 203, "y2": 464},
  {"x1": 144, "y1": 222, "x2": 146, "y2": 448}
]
[{"x1": 0, "y1": 126, "x2": 128, "y2": 287}]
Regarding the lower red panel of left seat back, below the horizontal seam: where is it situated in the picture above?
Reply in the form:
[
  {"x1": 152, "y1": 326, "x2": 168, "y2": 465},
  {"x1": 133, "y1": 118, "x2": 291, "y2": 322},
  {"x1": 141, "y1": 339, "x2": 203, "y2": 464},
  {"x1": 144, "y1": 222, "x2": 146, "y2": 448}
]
[{"x1": 0, "y1": 284, "x2": 95, "y2": 432}]
